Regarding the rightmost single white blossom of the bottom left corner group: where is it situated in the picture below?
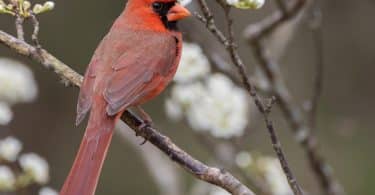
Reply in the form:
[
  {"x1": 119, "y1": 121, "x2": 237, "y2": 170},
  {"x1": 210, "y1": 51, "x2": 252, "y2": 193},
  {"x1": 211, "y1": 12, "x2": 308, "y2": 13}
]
[{"x1": 19, "y1": 153, "x2": 49, "y2": 184}]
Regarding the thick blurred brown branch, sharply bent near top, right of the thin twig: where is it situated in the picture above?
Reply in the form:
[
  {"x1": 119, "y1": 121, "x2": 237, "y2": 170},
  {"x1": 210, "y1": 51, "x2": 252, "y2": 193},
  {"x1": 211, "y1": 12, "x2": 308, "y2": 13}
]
[{"x1": 245, "y1": 0, "x2": 344, "y2": 195}]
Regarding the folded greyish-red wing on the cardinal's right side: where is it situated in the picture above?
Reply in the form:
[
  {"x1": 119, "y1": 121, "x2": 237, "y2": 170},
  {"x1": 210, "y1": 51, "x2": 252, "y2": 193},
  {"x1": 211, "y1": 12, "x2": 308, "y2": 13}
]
[{"x1": 104, "y1": 33, "x2": 177, "y2": 115}]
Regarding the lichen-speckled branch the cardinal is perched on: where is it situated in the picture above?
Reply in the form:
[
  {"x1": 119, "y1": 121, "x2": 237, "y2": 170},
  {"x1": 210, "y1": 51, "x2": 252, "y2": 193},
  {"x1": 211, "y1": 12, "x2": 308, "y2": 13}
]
[{"x1": 0, "y1": 31, "x2": 254, "y2": 195}]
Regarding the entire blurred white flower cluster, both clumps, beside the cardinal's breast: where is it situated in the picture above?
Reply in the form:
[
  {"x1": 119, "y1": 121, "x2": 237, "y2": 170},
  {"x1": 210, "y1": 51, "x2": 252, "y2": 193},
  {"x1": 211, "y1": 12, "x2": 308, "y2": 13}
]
[{"x1": 165, "y1": 43, "x2": 248, "y2": 138}]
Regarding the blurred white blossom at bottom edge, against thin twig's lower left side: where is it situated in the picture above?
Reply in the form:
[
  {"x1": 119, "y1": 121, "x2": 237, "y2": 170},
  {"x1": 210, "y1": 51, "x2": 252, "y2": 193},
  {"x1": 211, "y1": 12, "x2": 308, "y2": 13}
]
[{"x1": 257, "y1": 157, "x2": 293, "y2": 195}]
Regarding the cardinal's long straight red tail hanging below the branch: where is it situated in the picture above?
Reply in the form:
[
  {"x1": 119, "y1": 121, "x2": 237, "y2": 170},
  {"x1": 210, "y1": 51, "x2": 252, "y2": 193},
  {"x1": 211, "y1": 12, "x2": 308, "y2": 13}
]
[{"x1": 60, "y1": 100, "x2": 118, "y2": 195}]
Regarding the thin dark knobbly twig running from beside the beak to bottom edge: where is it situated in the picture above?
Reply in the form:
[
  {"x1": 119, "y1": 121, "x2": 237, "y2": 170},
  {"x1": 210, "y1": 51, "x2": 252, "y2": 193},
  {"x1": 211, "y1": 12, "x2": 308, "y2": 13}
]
[{"x1": 197, "y1": 0, "x2": 303, "y2": 195}]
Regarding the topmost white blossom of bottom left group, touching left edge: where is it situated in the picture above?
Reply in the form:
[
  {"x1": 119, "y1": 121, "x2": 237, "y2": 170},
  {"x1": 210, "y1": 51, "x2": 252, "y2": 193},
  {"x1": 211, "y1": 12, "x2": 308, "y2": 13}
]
[{"x1": 0, "y1": 137, "x2": 22, "y2": 162}]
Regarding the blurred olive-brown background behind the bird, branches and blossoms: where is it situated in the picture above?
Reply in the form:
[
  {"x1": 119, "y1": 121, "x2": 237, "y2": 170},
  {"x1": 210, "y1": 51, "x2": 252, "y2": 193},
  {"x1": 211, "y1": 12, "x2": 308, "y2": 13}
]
[{"x1": 0, "y1": 0, "x2": 375, "y2": 195}]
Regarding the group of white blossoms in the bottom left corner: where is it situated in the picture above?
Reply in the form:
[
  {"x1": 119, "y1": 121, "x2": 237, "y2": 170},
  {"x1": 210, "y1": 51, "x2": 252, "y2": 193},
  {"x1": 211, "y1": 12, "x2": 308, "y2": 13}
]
[{"x1": 0, "y1": 137, "x2": 53, "y2": 191}]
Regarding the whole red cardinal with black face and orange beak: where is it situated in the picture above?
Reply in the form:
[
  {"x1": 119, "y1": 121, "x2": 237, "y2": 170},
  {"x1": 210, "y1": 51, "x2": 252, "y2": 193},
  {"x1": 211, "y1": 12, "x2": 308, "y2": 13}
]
[{"x1": 60, "y1": 0, "x2": 190, "y2": 195}]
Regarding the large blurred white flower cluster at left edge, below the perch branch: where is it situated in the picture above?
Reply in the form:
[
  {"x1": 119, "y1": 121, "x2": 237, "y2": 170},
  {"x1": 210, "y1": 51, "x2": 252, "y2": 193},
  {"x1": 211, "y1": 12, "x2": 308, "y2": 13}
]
[{"x1": 0, "y1": 58, "x2": 38, "y2": 125}]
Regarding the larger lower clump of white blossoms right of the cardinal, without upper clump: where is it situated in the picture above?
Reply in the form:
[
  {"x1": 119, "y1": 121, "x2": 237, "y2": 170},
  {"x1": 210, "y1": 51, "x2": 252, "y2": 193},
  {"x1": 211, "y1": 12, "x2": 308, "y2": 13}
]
[{"x1": 167, "y1": 74, "x2": 248, "y2": 138}]
